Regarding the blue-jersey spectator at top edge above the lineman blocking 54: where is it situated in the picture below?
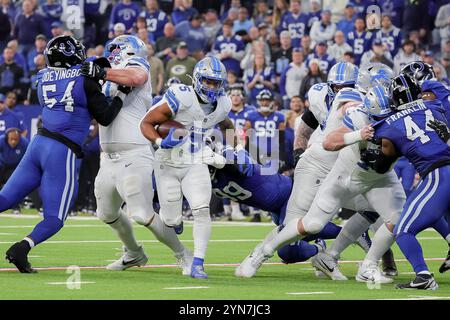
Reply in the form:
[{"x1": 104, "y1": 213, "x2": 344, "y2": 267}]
[{"x1": 109, "y1": 0, "x2": 141, "y2": 39}]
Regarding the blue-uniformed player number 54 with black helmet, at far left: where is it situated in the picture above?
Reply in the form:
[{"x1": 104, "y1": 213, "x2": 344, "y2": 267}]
[{"x1": 0, "y1": 36, "x2": 126, "y2": 273}]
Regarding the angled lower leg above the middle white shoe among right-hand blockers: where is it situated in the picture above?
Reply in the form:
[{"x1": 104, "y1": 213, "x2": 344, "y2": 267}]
[{"x1": 327, "y1": 213, "x2": 371, "y2": 259}]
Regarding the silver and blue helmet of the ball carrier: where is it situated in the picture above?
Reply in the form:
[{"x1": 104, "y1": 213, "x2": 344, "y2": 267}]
[{"x1": 192, "y1": 57, "x2": 227, "y2": 103}]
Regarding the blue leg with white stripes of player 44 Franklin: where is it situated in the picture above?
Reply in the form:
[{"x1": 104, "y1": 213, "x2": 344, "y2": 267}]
[{"x1": 395, "y1": 166, "x2": 450, "y2": 290}]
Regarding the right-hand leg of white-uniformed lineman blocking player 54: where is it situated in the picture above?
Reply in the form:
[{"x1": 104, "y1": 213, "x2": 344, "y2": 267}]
[{"x1": 117, "y1": 154, "x2": 192, "y2": 275}]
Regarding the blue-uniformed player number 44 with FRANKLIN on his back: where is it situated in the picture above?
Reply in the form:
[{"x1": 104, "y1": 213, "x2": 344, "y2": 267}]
[{"x1": 364, "y1": 75, "x2": 450, "y2": 290}]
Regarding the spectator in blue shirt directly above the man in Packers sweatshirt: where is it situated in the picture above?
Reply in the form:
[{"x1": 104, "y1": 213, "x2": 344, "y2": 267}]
[{"x1": 175, "y1": 13, "x2": 208, "y2": 60}]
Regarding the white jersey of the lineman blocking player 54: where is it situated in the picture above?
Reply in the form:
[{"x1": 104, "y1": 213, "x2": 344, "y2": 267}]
[{"x1": 99, "y1": 56, "x2": 152, "y2": 153}]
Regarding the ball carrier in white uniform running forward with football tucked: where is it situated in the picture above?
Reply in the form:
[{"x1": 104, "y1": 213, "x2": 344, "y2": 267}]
[{"x1": 140, "y1": 57, "x2": 237, "y2": 279}]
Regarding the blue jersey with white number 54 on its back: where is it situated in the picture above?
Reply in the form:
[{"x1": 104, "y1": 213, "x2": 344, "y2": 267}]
[{"x1": 37, "y1": 65, "x2": 91, "y2": 145}]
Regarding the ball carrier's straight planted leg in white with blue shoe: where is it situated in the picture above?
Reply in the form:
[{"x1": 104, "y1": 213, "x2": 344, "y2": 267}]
[{"x1": 181, "y1": 164, "x2": 212, "y2": 278}]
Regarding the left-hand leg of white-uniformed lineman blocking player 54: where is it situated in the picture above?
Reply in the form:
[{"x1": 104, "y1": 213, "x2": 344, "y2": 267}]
[{"x1": 94, "y1": 158, "x2": 148, "y2": 270}]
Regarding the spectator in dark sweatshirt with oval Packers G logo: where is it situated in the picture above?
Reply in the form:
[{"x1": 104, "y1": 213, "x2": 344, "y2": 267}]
[{"x1": 166, "y1": 41, "x2": 197, "y2": 85}]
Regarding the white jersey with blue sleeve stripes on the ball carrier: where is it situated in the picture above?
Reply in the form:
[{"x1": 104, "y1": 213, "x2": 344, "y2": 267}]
[{"x1": 152, "y1": 84, "x2": 231, "y2": 167}]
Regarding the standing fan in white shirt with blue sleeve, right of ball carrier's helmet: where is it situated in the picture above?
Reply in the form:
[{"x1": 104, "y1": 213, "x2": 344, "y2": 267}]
[{"x1": 280, "y1": 48, "x2": 308, "y2": 109}]
